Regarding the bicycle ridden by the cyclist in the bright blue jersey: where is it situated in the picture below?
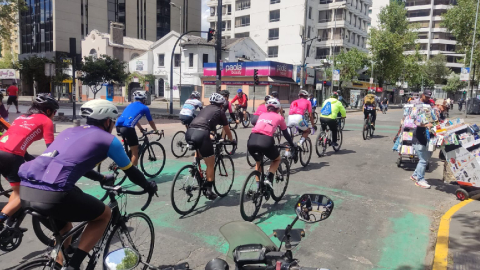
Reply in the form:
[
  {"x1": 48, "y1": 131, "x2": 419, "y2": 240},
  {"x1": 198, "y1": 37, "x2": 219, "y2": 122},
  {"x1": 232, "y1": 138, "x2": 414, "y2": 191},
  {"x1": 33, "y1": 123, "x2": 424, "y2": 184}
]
[{"x1": 97, "y1": 130, "x2": 166, "y2": 180}]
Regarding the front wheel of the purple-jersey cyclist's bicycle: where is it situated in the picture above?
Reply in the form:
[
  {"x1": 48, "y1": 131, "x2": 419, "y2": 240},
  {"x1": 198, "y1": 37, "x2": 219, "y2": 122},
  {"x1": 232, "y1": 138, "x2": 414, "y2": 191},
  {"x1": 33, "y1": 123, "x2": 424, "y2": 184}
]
[{"x1": 103, "y1": 212, "x2": 155, "y2": 270}]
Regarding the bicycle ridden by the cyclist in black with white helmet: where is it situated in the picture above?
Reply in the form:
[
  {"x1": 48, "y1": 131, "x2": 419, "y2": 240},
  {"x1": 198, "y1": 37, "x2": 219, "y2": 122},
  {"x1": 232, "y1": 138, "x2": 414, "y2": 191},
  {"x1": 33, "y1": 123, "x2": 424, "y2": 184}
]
[{"x1": 170, "y1": 138, "x2": 235, "y2": 216}]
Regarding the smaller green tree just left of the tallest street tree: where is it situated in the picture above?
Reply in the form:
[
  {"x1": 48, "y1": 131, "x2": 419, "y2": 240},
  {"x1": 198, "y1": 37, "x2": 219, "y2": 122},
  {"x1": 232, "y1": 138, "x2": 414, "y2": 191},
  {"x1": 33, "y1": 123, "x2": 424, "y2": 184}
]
[{"x1": 335, "y1": 48, "x2": 367, "y2": 88}]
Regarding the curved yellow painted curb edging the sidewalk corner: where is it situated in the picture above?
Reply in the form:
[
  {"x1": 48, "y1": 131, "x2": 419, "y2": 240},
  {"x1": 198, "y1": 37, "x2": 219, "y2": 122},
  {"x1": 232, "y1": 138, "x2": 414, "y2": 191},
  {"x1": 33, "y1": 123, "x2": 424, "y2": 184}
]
[{"x1": 432, "y1": 199, "x2": 473, "y2": 270}]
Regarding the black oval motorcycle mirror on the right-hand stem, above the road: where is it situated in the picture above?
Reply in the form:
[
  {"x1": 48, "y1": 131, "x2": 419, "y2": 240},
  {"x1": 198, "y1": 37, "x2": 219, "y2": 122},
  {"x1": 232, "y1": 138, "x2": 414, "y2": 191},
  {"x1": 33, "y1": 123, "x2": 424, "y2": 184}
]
[{"x1": 295, "y1": 194, "x2": 334, "y2": 223}]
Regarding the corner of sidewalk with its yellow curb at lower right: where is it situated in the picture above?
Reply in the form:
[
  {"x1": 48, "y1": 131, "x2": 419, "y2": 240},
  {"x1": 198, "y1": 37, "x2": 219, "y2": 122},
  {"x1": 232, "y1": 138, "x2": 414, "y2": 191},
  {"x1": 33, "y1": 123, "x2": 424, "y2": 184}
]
[{"x1": 432, "y1": 200, "x2": 480, "y2": 270}]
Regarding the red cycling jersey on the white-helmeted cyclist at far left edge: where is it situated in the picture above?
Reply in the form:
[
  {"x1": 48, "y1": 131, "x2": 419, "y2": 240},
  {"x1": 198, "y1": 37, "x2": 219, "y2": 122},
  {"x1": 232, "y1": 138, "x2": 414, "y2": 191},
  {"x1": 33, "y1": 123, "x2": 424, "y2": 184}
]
[{"x1": 0, "y1": 114, "x2": 54, "y2": 157}]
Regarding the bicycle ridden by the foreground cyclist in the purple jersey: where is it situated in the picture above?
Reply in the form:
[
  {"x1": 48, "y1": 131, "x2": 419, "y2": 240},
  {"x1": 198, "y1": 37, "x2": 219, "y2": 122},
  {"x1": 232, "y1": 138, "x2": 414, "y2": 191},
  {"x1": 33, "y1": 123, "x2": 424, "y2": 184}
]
[{"x1": 16, "y1": 186, "x2": 155, "y2": 270}]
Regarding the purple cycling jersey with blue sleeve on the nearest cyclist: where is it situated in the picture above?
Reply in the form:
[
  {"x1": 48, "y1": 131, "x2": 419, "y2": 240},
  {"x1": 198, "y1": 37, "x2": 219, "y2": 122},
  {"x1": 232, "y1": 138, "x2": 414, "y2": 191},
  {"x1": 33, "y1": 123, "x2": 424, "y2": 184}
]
[{"x1": 18, "y1": 126, "x2": 132, "y2": 191}]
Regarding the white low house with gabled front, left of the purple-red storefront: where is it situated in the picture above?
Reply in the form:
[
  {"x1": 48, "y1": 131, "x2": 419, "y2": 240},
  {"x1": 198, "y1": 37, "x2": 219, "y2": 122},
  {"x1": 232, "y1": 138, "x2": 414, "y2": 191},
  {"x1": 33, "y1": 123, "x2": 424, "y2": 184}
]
[{"x1": 129, "y1": 31, "x2": 266, "y2": 100}]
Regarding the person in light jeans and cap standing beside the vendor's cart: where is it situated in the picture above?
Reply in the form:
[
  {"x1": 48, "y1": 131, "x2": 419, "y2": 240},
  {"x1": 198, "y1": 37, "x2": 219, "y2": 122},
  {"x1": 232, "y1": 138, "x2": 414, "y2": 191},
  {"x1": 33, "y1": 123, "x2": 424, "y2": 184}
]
[{"x1": 410, "y1": 90, "x2": 433, "y2": 189}]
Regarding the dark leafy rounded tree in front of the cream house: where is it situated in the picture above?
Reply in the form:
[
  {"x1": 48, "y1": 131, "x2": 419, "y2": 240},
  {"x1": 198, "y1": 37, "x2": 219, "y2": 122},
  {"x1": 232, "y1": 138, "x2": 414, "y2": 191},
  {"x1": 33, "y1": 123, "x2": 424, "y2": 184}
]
[{"x1": 79, "y1": 55, "x2": 128, "y2": 99}]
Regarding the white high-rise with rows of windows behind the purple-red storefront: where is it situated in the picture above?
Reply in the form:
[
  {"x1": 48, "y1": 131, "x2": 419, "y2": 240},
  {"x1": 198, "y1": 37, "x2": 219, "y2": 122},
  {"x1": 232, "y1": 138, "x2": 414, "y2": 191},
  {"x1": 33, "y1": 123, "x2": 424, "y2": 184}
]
[{"x1": 207, "y1": 0, "x2": 372, "y2": 64}]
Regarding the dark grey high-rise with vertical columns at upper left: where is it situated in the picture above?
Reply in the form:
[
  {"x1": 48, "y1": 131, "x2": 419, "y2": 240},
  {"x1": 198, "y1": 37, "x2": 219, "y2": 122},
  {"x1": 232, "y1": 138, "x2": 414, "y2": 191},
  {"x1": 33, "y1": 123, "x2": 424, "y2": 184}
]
[{"x1": 19, "y1": 0, "x2": 201, "y2": 59}]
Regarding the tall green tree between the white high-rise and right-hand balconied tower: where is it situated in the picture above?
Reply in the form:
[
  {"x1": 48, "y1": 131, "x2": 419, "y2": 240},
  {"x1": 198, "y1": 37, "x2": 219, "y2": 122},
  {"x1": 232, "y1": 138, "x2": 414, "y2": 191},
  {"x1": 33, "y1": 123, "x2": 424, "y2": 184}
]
[{"x1": 369, "y1": 1, "x2": 418, "y2": 86}]
